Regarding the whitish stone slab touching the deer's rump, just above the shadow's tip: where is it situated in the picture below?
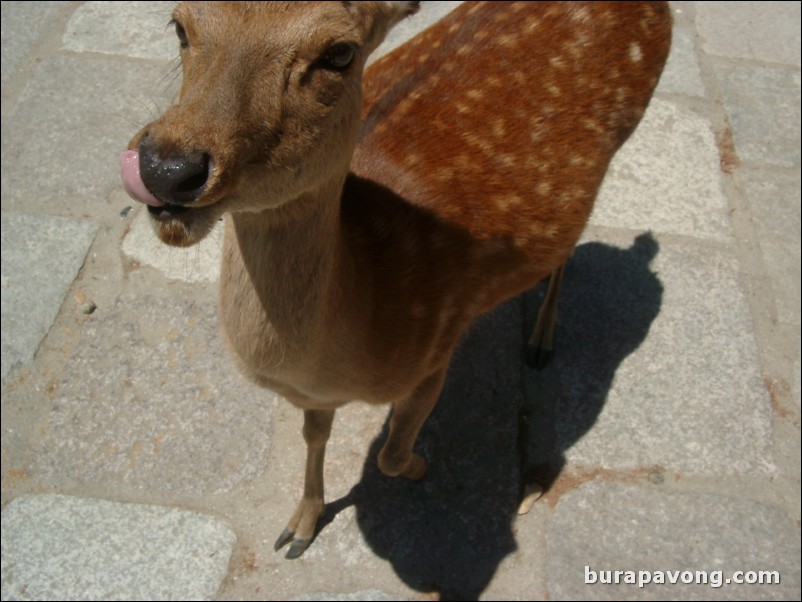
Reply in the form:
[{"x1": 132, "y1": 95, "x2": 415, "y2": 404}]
[{"x1": 591, "y1": 98, "x2": 730, "y2": 240}]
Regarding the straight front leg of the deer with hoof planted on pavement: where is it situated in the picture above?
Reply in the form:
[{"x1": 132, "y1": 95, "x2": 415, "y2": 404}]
[{"x1": 273, "y1": 410, "x2": 334, "y2": 559}]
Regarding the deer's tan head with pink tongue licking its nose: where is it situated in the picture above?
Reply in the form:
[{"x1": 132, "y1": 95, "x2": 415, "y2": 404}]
[{"x1": 121, "y1": 2, "x2": 417, "y2": 246}]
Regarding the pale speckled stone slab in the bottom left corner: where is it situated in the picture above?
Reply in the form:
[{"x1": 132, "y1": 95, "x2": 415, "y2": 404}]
[{"x1": 2, "y1": 495, "x2": 236, "y2": 600}]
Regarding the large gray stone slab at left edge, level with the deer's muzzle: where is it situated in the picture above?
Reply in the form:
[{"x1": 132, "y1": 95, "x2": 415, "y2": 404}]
[{"x1": 2, "y1": 56, "x2": 177, "y2": 217}]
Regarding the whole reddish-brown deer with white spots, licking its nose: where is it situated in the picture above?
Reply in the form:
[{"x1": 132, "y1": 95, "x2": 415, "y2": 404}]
[{"x1": 120, "y1": 1, "x2": 671, "y2": 558}]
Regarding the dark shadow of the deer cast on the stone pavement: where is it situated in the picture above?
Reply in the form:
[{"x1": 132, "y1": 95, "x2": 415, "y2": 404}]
[{"x1": 319, "y1": 234, "x2": 663, "y2": 600}]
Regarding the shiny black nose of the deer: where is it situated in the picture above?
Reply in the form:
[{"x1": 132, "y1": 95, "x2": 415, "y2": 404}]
[{"x1": 139, "y1": 136, "x2": 210, "y2": 205}]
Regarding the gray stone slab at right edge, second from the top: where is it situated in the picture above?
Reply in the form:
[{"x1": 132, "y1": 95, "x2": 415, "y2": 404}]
[{"x1": 713, "y1": 61, "x2": 800, "y2": 167}]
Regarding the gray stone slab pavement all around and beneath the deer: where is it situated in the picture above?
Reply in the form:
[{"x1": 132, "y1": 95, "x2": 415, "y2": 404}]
[{"x1": 2, "y1": 1, "x2": 800, "y2": 600}]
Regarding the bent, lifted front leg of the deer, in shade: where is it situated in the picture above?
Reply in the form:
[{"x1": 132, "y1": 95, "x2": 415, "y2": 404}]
[{"x1": 379, "y1": 369, "x2": 446, "y2": 481}]
